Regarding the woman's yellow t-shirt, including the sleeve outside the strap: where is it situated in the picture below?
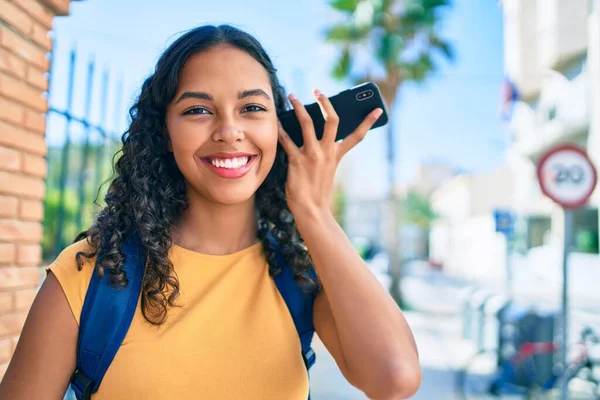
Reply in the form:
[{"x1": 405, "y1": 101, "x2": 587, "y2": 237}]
[{"x1": 48, "y1": 240, "x2": 309, "y2": 400}]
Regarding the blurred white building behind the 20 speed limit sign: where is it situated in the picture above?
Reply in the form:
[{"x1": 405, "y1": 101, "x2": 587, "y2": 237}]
[{"x1": 502, "y1": 0, "x2": 600, "y2": 261}]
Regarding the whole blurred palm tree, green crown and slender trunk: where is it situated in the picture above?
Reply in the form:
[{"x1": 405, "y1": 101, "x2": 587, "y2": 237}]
[{"x1": 326, "y1": 0, "x2": 454, "y2": 304}]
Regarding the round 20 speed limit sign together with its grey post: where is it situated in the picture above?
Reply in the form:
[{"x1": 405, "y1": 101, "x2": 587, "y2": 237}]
[{"x1": 537, "y1": 145, "x2": 598, "y2": 400}]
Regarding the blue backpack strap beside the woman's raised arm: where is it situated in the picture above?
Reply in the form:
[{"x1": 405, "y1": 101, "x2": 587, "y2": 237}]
[{"x1": 268, "y1": 236, "x2": 317, "y2": 370}]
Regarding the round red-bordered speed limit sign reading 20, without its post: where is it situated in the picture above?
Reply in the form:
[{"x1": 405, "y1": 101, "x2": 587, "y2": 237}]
[{"x1": 537, "y1": 145, "x2": 598, "y2": 208}]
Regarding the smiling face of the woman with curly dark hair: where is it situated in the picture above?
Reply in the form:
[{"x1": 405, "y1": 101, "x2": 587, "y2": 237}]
[{"x1": 166, "y1": 46, "x2": 277, "y2": 204}]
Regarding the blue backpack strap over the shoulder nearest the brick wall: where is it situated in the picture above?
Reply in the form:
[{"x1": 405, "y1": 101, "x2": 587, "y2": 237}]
[{"x1": 71, "y1": 238, "x2": 146, "y2": 400}]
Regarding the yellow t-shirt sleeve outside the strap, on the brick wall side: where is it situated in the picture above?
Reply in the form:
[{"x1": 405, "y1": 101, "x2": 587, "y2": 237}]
[{"x1": 46, "y1": 239, "x2": 96, "y2": 325}]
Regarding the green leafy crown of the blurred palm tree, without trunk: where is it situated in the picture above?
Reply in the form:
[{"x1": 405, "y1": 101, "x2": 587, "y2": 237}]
[{"x1": 325, "y1": 0, "x2": 454, "y2": 87}]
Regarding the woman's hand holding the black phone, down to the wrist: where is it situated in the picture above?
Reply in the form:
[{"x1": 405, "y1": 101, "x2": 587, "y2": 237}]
[{"x1": 279, "y1": 89, "x2": 383, "y2": 218}]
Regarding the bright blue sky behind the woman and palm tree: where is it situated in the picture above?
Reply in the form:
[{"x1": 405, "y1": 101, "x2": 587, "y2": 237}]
[{"x1": 48, "y1": 0, "x2": 506, "y2": 198}]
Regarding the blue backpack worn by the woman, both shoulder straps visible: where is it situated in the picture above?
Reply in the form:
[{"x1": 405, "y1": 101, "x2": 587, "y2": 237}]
[{"x1": 71, "y1": 236, "x2": 316, "y2": 400}]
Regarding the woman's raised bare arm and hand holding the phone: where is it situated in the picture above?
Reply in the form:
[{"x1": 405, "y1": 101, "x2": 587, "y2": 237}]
[{"x1": 279, "y1": 92, "x2": 421, "y2": 399}]
